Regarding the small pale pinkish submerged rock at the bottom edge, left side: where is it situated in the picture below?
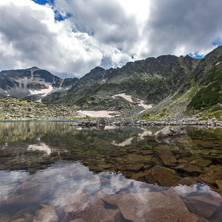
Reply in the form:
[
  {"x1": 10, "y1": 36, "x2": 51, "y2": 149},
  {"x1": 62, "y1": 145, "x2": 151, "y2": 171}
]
[{"x1": 33, "y1": 205, "x2": 59, "y2": 222}]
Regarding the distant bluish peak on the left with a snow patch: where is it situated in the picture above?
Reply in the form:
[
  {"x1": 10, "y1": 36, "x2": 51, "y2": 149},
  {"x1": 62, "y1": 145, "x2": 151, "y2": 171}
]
[{"x1": 0, "y1": 67, "x2": 78, "y2": 101}]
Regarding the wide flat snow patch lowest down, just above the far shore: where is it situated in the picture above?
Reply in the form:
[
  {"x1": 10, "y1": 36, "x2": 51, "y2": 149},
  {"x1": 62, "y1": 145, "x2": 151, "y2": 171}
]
[{"x1": 77, "y1": 110, "x2": 119, "y2": 118}]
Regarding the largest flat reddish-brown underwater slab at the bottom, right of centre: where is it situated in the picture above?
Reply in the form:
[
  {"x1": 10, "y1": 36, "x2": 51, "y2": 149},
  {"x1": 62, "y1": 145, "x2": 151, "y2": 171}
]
[{"x1": 103, "y1": 190, "x2": 204, "y2": 222}]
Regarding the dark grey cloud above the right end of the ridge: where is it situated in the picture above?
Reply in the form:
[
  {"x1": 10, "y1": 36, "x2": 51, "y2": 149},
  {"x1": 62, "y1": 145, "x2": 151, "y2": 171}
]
[{"x1": 144, "y1": 0, "x2": 222, "y2": 56}]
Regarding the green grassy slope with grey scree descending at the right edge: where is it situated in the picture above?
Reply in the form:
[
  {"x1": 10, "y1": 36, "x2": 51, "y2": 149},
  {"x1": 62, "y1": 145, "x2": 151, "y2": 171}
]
[{"x1": 141, "y1": 46, "x2": 222, "y2": 120}]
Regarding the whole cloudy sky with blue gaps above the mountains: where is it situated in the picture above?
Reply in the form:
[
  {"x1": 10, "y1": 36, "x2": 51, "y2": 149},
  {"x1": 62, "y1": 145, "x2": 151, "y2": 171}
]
[{"x1": 0, "y1": 0, "x2": 222, "y2": 78}]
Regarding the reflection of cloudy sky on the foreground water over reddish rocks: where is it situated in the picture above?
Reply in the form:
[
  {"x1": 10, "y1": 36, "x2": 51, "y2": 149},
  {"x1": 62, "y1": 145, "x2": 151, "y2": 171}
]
[{"x1": 0, "y1": 161, "x2": 222, "y2": 222}]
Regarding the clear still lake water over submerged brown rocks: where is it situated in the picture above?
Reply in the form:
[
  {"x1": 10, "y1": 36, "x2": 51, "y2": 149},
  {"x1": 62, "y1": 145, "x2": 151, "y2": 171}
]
[{"x1": 0, "y1": 122, "x2": 222, "y2": 222}]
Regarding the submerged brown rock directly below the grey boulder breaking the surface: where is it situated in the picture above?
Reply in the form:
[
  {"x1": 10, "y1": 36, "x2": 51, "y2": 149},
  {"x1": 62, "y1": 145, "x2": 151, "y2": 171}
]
[{"x1": 154, "y1": 145, "x2": 177, "y2": 166}]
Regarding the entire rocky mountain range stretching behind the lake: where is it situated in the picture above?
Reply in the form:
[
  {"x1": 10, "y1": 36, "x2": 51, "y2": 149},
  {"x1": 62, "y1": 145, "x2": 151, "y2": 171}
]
[{"x1": 0, "y1": 46, "x2": 222, "y2": 120}]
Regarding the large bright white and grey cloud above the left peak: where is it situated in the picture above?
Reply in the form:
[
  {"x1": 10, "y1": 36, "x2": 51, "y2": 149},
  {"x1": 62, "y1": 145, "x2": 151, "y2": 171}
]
[{"x1": 0, "y1": 0, "x2": 130, "y2": 77}]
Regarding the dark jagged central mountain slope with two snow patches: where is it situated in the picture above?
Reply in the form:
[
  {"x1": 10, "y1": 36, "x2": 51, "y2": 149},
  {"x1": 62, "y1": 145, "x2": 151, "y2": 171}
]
[{"x1": 43, "y1": 55, "x2": 199, "y2": 114}]
